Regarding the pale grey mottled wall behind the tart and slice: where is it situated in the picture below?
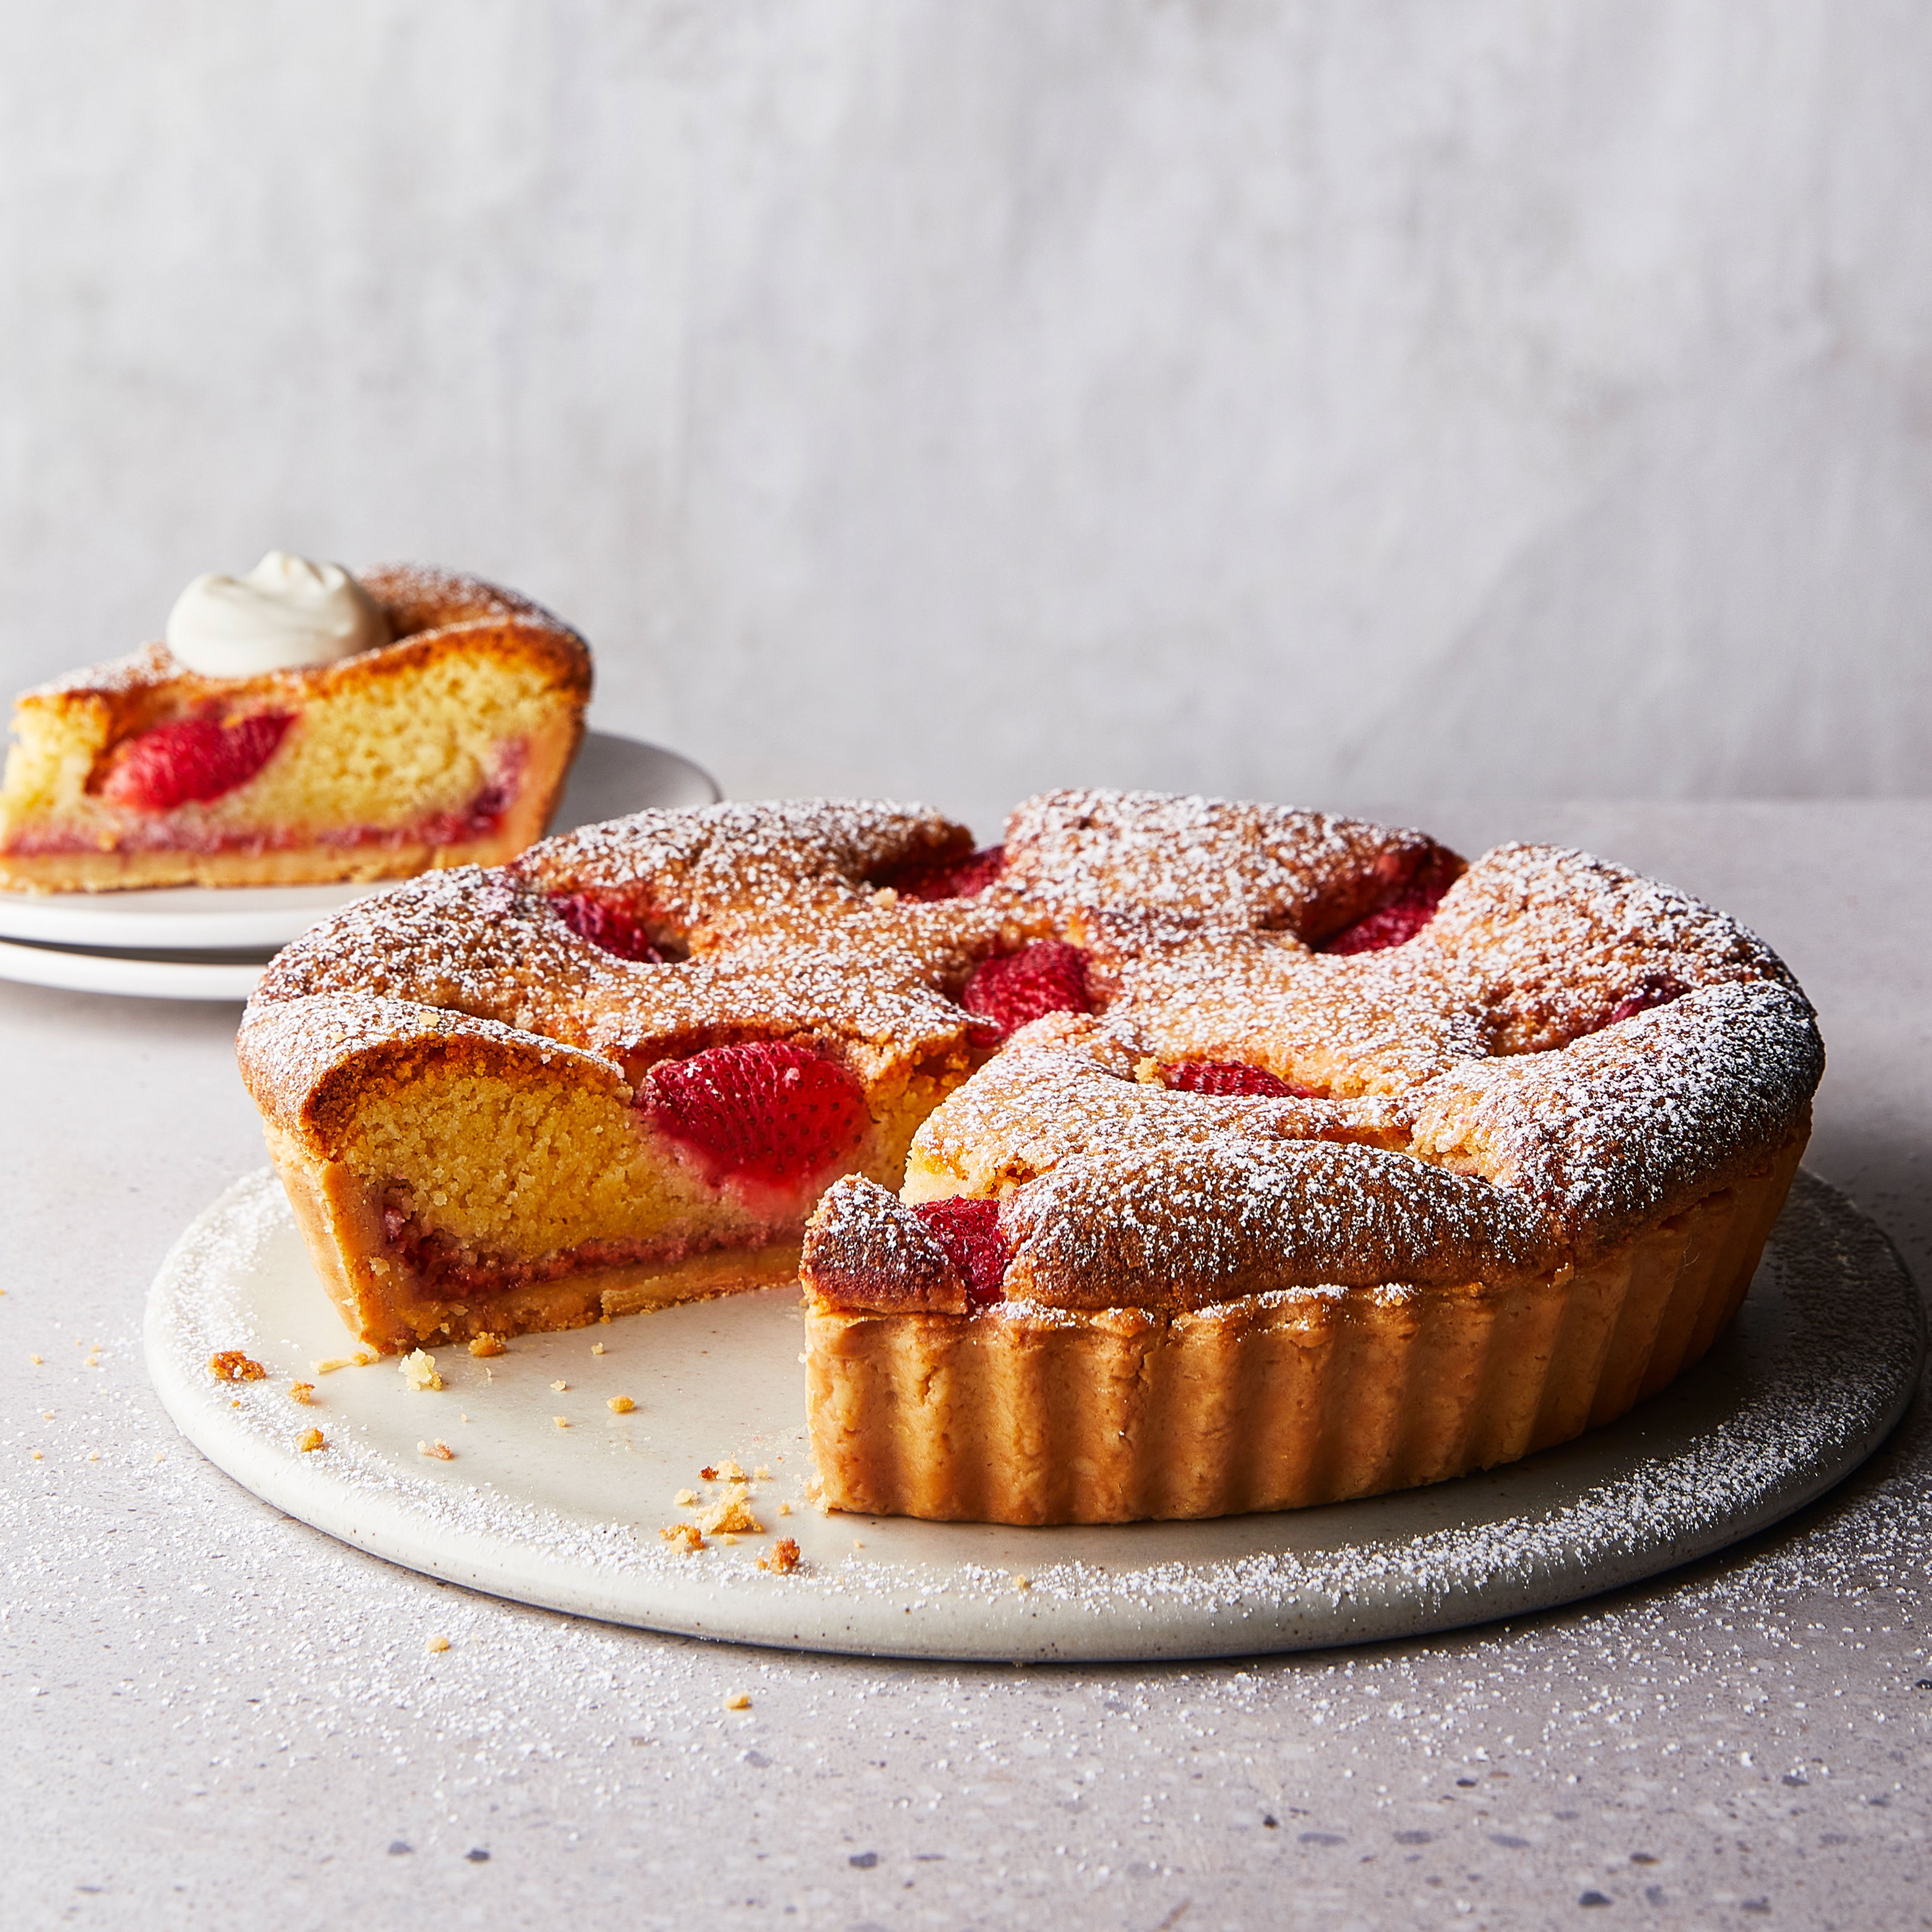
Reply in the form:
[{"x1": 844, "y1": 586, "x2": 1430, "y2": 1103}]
[{"x1": 0, "y1": 0, "x2": 1932, "y2": 829}]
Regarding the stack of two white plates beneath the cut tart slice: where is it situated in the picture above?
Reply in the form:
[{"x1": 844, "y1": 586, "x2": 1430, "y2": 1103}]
[{"x1": 0, "y1": 732, "x2": 719, "y2": 999}]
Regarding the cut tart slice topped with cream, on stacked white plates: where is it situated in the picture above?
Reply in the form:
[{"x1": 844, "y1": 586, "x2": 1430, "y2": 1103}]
[{"x1": 0, "y1": 551, "x2": 591, "y2": 893}]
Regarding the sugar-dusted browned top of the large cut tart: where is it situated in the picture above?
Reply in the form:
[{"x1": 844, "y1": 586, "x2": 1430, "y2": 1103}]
[{"x1": 242, "y1": 792, "x2": 1824, "y2": 1310}]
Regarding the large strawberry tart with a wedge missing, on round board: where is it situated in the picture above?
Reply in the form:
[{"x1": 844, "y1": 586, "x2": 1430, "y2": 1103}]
[{"x1": 240, "y1": 792, "x2": 1824, "y2": 1522}]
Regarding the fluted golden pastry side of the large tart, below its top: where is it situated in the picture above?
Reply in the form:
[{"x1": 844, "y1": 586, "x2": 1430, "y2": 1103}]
[{"x1": 806, "y1": 1132, "x2": 1807, "y2": 1525}]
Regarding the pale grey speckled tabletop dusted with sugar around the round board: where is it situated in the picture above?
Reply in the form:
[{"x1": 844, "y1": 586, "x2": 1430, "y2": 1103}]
[{"x1": 0, "y1": 802, "x2": 1932, "y2": 1932}]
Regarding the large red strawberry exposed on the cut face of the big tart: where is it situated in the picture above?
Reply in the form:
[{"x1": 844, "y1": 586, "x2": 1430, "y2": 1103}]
[{"x1": 638, "y1": 1039, "x2": 869, "y2": 1188}]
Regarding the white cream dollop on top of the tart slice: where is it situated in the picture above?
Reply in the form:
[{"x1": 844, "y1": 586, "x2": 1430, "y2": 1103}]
[{"x1": 168, "y1": 551, "x2": 390, "y2": 678}]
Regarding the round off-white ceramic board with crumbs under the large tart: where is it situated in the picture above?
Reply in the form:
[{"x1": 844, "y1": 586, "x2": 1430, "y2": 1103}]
[{"x1": 147, "y1": 1173, "x2": 1924, "y2": 1662}]
